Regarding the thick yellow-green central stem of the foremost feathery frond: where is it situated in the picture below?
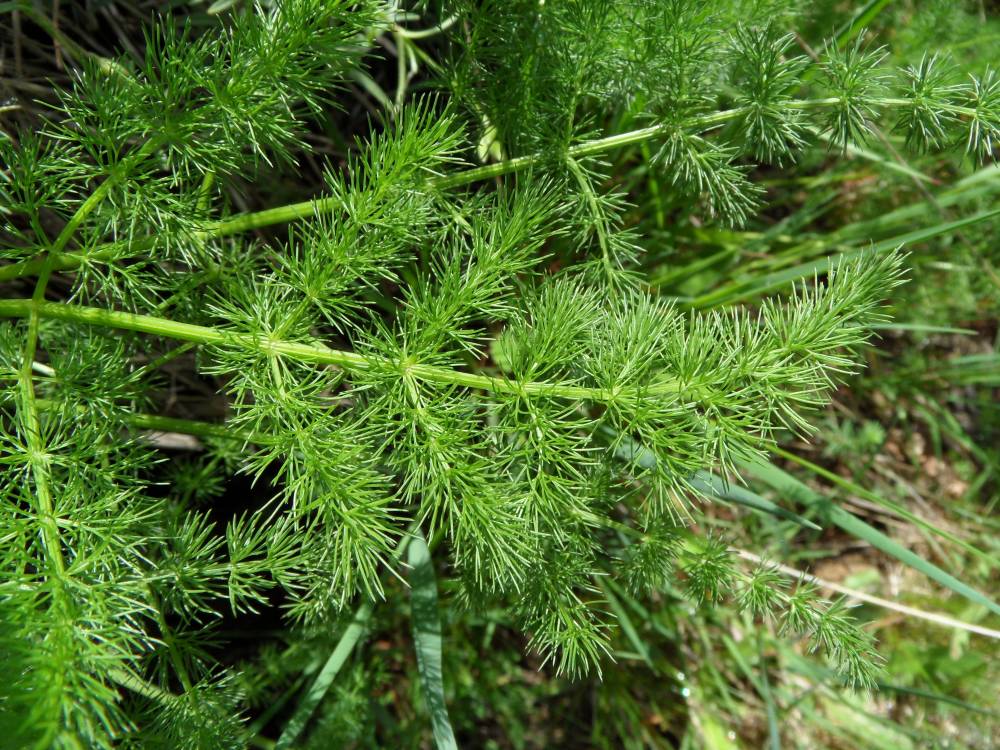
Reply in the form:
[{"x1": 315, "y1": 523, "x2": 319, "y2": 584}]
[{"x1": 0, "y1": 299, "x2": 694, "y2": 403}]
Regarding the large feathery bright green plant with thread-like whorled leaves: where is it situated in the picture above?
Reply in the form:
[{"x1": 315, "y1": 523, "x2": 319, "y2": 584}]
[{"x1": 0, "y1": 0, "x2": 1000, "y2": 748}]
